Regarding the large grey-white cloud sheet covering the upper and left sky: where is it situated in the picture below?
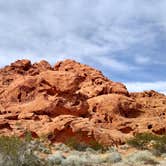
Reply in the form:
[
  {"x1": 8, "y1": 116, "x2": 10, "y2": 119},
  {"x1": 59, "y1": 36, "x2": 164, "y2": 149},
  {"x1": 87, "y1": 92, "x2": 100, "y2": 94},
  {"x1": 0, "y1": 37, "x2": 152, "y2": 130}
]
[{"x1": 0, "y1": 0, "x2": 166, "y2": 70}]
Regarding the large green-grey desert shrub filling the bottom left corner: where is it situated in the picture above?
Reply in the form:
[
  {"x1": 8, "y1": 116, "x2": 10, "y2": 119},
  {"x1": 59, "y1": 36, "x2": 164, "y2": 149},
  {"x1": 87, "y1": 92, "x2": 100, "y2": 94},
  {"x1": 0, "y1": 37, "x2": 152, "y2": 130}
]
[{"x1": 0, "y1": 133, "x2": 42, "y2": 166}]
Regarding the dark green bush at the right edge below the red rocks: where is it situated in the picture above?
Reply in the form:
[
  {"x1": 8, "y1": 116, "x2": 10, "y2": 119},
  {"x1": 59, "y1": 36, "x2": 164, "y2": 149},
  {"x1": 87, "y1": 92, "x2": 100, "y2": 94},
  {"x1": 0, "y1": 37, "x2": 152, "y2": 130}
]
[{"x1": 127, "y1": 133, "x2": 166, "y2": 155}]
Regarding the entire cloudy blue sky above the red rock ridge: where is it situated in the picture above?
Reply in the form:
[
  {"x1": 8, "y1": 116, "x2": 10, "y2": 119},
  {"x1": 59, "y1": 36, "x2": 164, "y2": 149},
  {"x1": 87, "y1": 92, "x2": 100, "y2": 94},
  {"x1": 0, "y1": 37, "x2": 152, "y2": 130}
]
[{"x1": 0, "y1": 0, "x2": 166, "y2": 93}]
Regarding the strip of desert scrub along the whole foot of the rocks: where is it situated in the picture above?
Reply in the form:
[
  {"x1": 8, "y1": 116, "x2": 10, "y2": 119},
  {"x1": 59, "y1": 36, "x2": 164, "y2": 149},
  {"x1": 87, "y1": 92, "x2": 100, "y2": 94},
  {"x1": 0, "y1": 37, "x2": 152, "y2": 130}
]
[{"x1": 0, "y1": 132, "x2": 166, "y2": 166}]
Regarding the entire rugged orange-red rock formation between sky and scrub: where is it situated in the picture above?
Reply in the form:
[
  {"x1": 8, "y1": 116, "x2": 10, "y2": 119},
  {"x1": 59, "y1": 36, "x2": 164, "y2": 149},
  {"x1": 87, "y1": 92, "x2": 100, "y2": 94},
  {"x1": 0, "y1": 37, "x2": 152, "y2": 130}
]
[{"x1": 0, "y1": 60, "x2": 166, "y2": 145}]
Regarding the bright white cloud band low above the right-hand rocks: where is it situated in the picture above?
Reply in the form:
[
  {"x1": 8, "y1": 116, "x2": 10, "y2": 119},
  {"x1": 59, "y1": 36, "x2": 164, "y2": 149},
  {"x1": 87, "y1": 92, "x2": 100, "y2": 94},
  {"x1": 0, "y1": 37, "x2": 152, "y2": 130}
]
[{"x1": 125, "y1": 81, "x2": 166, "y2": 94}]
